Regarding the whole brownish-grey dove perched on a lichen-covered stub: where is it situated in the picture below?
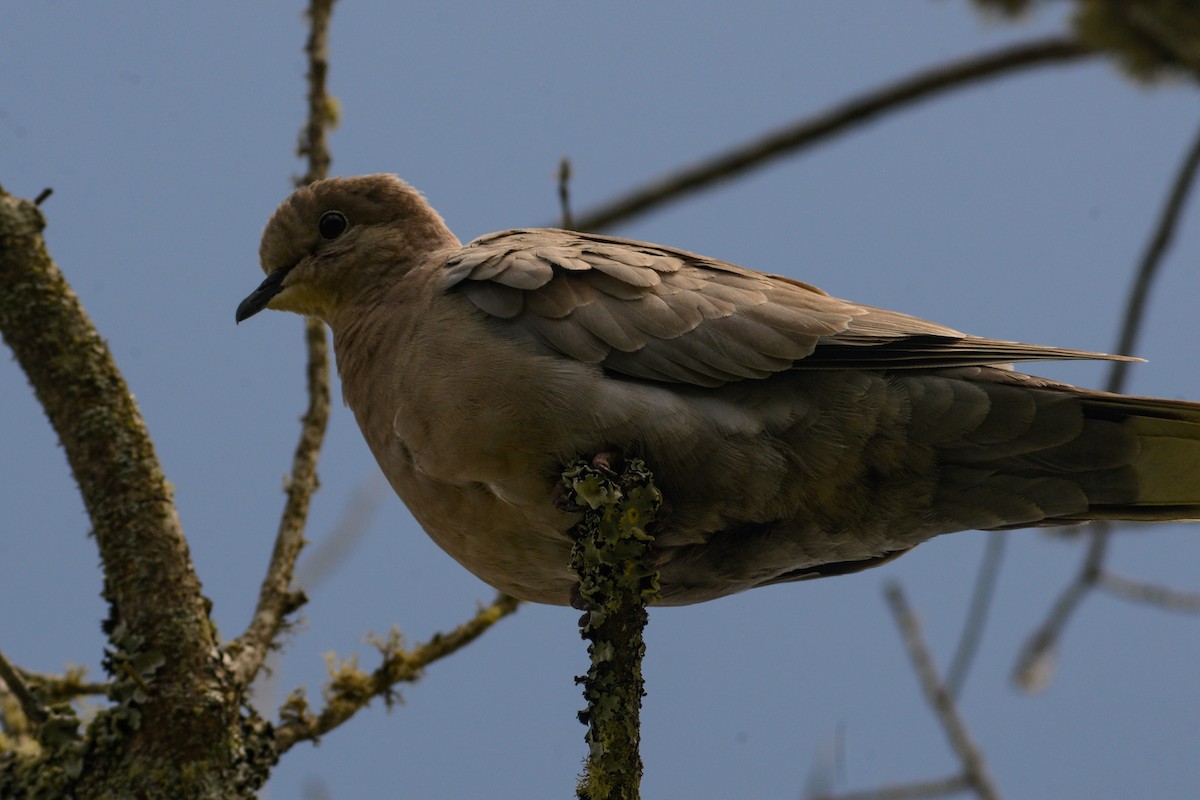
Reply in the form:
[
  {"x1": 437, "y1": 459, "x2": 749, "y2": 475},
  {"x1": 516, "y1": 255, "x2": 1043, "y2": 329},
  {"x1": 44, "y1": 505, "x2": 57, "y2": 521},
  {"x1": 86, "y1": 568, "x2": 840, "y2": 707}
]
[{"x1": 236, "y1": 174, "x2": 1200, "y2": 604}]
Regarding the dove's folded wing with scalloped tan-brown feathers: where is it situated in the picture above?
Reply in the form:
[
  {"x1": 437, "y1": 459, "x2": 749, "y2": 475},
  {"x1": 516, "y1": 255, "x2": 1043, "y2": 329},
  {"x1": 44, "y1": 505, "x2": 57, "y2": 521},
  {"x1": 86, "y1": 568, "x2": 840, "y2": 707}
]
[{"x1": 445, "y1": 229, "x2": 1118, "y2": 386}]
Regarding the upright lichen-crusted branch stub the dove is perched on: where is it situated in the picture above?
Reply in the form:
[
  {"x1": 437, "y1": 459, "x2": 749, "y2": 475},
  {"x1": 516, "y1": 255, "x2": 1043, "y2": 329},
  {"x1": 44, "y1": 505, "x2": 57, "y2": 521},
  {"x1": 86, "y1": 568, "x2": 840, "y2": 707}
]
[{"x1": 563, "y1": 458, "x2": 662, "y2": 800}]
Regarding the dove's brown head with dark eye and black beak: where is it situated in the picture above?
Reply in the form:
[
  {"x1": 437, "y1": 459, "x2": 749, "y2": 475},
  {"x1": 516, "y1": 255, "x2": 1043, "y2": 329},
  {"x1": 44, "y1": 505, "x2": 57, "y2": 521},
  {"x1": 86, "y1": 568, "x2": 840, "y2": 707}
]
[{"x1": 236, "y1": 175, "x2": 458, "y2": 323}]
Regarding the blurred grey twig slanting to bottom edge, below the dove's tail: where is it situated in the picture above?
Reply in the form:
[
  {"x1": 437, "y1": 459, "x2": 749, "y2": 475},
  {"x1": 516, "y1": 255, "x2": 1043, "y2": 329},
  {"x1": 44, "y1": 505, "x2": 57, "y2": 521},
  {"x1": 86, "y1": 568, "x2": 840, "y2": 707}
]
[{"x1": 884, "y1": 583, "x2": 1000, "y2": 800}]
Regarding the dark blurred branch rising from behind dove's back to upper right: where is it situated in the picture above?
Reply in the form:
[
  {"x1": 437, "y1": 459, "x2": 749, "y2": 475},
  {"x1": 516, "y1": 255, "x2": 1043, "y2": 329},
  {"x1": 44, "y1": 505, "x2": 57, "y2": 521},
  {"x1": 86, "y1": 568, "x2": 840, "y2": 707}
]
[{"x1": 575, "y1": 37, "x2": 1092, "y2": 230}]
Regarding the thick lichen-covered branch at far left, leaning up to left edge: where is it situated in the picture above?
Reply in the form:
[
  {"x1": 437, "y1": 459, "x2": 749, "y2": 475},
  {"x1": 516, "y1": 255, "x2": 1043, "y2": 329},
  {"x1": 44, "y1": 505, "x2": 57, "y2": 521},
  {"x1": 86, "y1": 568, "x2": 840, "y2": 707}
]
[{"x1": 0, "y1": 190, "x2": 238, "y2": 796}]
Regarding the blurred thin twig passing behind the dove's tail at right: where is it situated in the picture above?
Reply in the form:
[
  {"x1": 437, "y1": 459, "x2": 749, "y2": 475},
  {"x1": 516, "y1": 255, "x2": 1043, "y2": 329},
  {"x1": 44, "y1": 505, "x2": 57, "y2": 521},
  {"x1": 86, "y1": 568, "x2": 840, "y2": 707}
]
[{"x1": 1013, "y1": 120, "x2": 1200, "y2": 691}]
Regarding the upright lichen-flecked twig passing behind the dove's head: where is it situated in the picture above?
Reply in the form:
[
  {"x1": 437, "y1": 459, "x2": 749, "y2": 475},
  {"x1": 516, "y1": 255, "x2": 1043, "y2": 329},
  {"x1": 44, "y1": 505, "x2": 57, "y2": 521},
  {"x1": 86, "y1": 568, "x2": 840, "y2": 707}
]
[{"x1": 228, "y1": 0, "x2": 334, "y2": 687}]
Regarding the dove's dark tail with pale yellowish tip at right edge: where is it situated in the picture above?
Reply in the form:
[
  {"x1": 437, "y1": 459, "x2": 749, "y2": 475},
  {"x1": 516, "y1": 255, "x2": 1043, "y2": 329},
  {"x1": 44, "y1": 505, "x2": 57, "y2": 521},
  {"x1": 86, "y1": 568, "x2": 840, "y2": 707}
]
[{"x1": 930, "y1": 372, "x2": 1200, "y2": 530}]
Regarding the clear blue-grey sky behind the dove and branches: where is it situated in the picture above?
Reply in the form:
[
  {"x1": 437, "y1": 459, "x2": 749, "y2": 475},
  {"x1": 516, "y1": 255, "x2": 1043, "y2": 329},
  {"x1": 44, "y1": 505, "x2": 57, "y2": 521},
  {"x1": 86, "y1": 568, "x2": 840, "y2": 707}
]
[{"x1": 0, "y1": 0, "x2": 1200, "y2": 799}]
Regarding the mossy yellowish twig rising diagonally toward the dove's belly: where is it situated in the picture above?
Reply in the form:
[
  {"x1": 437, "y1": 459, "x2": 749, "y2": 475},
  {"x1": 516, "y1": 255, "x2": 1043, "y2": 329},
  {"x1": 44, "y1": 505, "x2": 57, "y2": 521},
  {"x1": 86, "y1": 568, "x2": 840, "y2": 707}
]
[{"x1": 276, "y1": 594, "x2": 520, "y2": 754}]
